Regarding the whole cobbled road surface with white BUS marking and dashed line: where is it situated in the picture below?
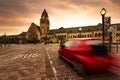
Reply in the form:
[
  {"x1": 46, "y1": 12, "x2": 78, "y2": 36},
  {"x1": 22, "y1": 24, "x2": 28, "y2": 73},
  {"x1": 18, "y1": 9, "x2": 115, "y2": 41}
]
[{"x1": 0, "y1": 44, "x2": 120, "y2": 80}]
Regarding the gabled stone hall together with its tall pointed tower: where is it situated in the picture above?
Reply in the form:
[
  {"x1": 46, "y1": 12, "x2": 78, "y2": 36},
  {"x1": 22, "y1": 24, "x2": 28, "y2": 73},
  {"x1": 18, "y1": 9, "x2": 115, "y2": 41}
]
[{"x1": 26, "y1": 9, "x2": 50, "y2": 41}]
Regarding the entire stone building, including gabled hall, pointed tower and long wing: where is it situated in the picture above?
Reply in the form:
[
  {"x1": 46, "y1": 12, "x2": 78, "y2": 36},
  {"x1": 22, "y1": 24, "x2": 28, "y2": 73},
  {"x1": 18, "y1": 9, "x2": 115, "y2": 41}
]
[{"x1": 26, "y1": 9, "x2": 120, "y2": 43}]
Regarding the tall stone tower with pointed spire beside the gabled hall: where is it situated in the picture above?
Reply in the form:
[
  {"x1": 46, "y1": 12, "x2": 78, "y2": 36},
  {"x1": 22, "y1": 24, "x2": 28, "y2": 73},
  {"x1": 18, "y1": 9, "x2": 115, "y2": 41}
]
[{"x1": 40, "y1": 9, "x2": 50, "y2": 35}]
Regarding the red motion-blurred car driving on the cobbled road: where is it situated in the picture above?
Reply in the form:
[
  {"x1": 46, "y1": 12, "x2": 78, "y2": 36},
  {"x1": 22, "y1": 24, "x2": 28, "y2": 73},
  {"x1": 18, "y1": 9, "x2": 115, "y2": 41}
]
[{"x1": 58, "y1": 38, "x2": 114, "y2": 73}]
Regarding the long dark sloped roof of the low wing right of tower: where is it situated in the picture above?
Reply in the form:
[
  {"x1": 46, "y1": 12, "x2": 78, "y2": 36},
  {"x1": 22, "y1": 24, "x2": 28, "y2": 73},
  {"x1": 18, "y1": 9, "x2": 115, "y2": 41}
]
[{"x1": 49, "y1": 23, "x2": 120, "y2": 34}]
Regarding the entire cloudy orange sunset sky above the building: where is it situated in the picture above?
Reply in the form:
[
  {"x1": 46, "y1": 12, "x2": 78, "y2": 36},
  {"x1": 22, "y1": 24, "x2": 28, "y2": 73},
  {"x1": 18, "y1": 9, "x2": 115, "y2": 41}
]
[{"x1": 0, "y1": 0, "x2": 120, "y2": 35}]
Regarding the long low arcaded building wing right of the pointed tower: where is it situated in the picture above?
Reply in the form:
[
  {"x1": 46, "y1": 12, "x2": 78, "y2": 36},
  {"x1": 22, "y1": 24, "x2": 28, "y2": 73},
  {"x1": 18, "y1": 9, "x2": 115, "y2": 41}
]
[{"x1": 49, "y1": 24, "x2": 120, "y2": 43}]
